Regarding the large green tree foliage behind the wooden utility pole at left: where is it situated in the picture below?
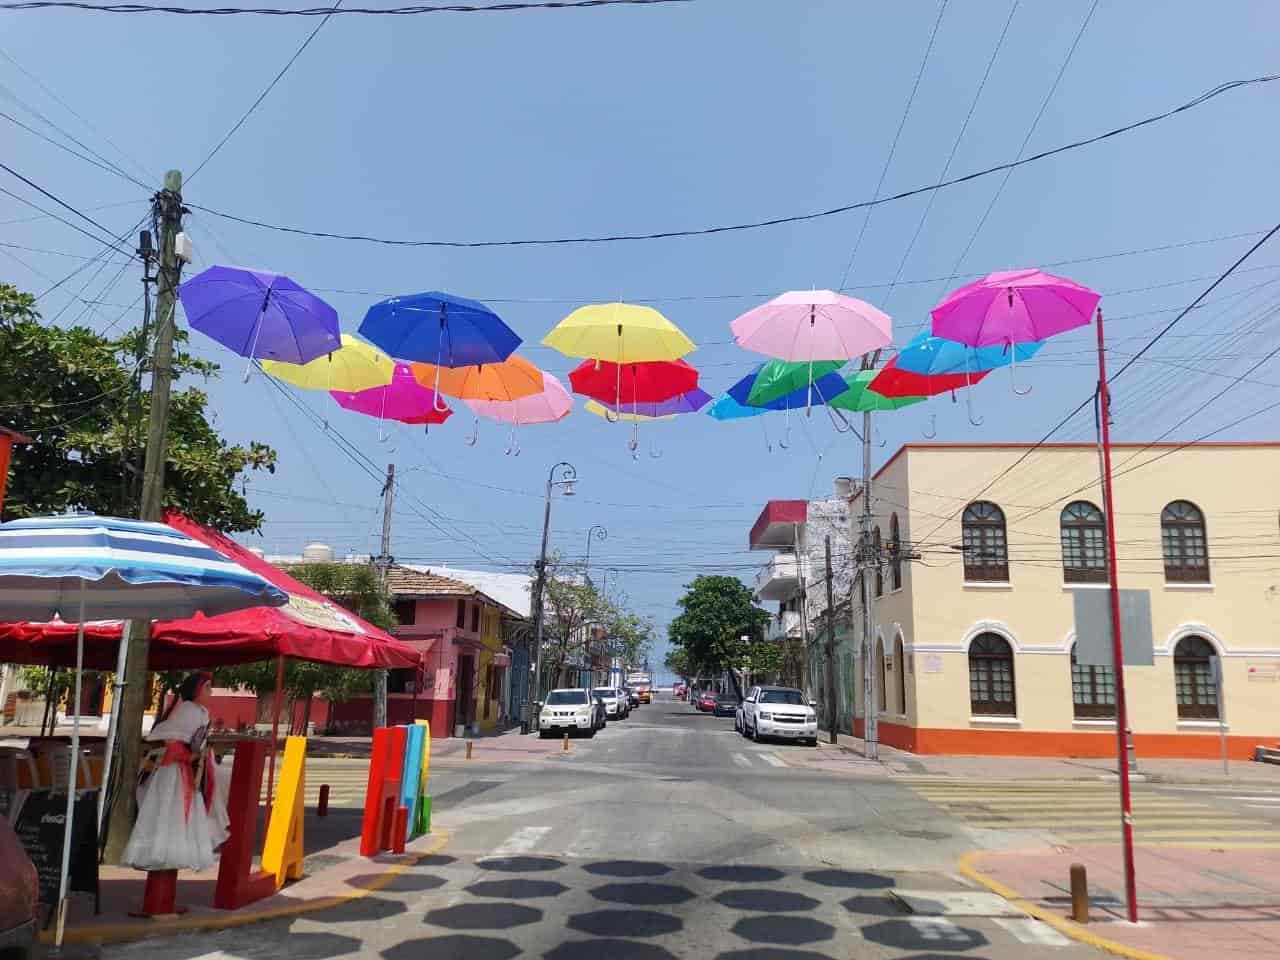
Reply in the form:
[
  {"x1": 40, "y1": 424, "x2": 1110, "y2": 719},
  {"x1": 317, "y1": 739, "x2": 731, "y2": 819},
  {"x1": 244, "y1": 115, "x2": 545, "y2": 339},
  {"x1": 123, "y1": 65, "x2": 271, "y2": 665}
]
[{"x1": 0, "y1": 283, "x2": 275, "y2": 532}]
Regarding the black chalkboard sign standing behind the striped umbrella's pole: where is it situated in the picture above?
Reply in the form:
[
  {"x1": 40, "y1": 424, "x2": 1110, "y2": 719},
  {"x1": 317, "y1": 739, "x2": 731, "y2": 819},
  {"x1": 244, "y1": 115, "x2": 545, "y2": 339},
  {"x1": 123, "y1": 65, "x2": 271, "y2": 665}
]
[{"x1": 14, "y1": 790, "x2": 97, "y2": 905}]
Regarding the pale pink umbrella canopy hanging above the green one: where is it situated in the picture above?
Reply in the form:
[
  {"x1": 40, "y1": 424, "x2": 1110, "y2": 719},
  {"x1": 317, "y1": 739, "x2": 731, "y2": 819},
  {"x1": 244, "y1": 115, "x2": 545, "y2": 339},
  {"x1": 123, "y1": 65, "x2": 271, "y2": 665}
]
[{"x1": 730, "y1": 291, "x2": 893, "y2": 362}]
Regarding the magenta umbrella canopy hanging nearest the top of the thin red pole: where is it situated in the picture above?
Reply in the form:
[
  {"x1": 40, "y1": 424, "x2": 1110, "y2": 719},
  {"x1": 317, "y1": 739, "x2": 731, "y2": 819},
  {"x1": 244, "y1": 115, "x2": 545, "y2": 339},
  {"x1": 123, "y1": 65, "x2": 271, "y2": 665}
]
[{"x1": 931, "y1": 270, "x2": 1102, "y2": 347}]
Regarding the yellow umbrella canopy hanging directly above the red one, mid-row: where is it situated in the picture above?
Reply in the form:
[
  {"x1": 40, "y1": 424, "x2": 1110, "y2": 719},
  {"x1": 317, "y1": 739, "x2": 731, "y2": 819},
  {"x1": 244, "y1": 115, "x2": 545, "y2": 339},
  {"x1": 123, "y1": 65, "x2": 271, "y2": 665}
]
[{"x1": 543, "y1": 303, "x2": 696, "y2": 364}]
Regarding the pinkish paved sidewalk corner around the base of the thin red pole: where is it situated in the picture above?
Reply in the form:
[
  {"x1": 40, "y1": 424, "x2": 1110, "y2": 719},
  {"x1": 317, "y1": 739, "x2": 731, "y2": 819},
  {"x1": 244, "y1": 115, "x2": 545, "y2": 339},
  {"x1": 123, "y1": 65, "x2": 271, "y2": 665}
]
[{"x1": 961, "y1": 845, "x2": 1280, "y2": 960}]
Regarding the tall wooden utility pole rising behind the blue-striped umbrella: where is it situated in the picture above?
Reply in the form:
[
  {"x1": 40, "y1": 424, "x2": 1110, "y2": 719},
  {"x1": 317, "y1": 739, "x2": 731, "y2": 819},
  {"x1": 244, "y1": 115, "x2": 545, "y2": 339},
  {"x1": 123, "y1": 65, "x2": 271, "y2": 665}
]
[{"x1": 104, "y1": 170, "x2": 184, "y2": 863}]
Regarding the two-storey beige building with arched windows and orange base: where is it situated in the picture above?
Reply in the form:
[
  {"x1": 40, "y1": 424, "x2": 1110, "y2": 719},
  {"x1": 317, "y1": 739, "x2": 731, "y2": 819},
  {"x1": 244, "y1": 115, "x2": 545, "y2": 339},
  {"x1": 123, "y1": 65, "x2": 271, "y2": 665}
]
[{"x1": 850, "y1": 443, "x2": 1280, "y2": 758}]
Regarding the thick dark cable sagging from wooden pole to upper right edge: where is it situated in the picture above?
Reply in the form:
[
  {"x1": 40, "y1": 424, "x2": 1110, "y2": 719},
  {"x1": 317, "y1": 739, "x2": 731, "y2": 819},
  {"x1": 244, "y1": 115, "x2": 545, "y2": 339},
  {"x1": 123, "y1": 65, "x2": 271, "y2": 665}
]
[{"x1": 186, "y1": 73, "x2": 1280, "y2": 248}]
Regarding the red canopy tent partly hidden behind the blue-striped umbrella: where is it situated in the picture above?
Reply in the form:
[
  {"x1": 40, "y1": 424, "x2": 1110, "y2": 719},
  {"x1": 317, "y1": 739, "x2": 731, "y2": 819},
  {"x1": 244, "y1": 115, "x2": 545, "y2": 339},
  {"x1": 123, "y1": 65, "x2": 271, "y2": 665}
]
[{"x1": 0, "y1": 513, "x2": 422, "y2": 669}]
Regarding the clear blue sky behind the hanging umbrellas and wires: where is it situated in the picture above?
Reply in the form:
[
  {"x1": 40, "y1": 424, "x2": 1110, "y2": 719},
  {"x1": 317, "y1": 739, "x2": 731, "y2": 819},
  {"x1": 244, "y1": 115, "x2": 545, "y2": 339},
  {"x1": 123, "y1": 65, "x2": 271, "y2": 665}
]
[{"x1": 0, "y1": 0, "x2": 1280, "y2": 680}]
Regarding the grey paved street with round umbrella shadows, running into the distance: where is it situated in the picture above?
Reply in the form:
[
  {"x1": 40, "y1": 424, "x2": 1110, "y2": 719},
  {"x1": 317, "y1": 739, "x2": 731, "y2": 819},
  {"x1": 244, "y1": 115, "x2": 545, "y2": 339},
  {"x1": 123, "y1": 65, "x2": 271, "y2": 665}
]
[{"x1": 104, "y1": 701, "x2": 1121, "y2": 960}]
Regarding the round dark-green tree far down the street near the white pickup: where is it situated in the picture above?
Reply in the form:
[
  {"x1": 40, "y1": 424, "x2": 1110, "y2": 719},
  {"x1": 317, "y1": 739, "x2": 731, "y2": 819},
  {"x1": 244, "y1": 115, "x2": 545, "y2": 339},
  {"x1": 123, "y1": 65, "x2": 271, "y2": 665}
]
[{"x1": 667, "y1": 576, "x2": 782, "y2": 696}]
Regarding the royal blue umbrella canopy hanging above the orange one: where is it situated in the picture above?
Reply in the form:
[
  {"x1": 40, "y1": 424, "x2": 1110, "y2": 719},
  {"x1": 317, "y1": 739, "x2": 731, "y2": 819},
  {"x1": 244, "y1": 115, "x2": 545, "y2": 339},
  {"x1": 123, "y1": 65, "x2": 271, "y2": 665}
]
[{"x1": 360, "y1": 291, "x2": 520, "y2": 367}]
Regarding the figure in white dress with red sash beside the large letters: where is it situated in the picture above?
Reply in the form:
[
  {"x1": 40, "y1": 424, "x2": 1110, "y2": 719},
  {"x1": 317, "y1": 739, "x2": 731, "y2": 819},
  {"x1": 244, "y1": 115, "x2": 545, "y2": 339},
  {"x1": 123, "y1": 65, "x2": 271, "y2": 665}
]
[{"x1": 123, "y1": 673, "x2": 229, "y2": 870}]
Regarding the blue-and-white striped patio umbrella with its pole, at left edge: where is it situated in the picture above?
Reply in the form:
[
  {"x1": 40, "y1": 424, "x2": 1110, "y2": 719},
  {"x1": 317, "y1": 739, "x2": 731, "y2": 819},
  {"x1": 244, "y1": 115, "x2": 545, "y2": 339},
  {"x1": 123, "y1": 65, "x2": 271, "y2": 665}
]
[{"x1": 0, "y1": 515, "x2": 288, "y2": 946}]
